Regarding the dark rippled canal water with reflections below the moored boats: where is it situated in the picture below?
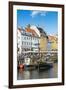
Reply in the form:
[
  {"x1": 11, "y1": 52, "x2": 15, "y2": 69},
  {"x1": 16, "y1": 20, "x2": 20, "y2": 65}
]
[{"x1": 17, "y1": 63, "x2": 58, "y2": 80}]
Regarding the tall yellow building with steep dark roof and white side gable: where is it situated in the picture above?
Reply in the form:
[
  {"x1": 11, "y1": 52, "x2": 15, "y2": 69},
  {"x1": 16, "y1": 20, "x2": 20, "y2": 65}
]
[{"x1": 30, "y1": 25, "x2": 48, "y2": 51}]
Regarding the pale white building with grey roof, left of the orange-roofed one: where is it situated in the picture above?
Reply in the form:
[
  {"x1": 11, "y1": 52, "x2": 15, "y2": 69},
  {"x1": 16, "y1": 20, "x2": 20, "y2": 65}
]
[{"x1": 21, "y1": 30, "x2": 32, "y2": 52}]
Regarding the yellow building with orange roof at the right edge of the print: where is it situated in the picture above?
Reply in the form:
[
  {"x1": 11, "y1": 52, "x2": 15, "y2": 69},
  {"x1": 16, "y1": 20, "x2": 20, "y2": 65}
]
[{"x1": 48, "y1": 36, "x2": 58, "y2": 50}]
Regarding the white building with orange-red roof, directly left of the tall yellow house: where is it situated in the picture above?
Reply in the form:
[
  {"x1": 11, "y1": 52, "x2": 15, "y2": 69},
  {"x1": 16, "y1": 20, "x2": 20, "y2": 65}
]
[{"x1": 26, "y1": 27, "x2": 39, "y2": 51}]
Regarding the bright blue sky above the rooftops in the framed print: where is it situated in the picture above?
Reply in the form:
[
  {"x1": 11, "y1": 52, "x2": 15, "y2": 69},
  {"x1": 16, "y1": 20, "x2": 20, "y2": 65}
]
[{"x1": 17, "y1": 10, "x2": 58, "y2": 35}]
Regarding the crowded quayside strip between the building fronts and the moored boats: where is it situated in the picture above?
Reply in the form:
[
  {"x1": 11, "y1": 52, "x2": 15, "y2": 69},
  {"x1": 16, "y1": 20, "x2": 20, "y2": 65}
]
[{"x1": 17, "y1": 51, "x2": 58, "y2": 63}]
